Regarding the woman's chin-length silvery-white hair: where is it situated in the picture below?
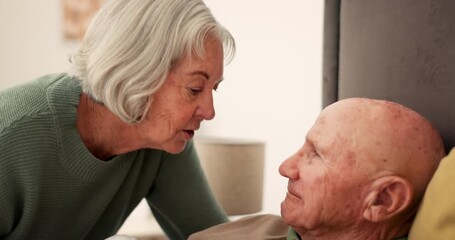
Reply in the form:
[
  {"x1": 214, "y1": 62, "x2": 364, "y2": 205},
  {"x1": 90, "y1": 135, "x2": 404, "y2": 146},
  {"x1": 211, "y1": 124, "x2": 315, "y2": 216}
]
[{"x1": 70, "y1": 0, "x2": 239, "y2": 123}]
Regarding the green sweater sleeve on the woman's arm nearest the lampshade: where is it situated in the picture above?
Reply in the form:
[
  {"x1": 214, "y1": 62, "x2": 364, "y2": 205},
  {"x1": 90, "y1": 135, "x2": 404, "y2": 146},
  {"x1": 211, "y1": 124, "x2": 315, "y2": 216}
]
[{"x1": 147, "y1": 141, "x2": 228, "y2": 239}]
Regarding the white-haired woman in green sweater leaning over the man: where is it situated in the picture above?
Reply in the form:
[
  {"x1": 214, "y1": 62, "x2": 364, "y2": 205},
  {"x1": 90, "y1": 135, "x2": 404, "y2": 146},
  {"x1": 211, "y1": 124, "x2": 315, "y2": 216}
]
[{"x1": 0, "y1": 0, "x2": 235, "y2": 239}]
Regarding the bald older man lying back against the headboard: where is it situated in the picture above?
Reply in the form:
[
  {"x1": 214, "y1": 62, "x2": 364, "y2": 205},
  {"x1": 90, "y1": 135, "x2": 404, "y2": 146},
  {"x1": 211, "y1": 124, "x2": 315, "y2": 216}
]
[{"x1": 190, "y1": 98, "x2": 445, "y2": 240}]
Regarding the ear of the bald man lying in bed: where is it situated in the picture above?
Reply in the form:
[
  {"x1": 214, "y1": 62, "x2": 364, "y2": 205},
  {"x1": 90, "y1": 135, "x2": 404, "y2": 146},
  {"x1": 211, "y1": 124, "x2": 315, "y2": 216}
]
[{"x1": 363, "y1": 176, "x2": 413, "y2": 222}]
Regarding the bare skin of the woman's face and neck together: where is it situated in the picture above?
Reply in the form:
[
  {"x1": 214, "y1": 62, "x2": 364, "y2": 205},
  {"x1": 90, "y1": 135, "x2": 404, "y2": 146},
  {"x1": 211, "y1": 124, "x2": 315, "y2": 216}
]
[{"x1": 77, "y1": 38, "x2": 224, "y2": 160}]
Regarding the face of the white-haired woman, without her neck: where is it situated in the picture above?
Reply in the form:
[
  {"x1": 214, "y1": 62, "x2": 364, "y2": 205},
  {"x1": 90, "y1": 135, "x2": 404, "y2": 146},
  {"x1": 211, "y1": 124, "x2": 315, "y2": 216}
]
[{"x1": 138, "y1": 40, "x2": 224, "y2": 153}]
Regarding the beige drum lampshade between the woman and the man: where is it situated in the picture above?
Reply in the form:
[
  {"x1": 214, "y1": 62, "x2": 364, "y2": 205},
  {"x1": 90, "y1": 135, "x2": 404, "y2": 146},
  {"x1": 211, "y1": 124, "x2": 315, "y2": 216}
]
[{"x1": 194, "y1": 138, "x2": 265, "y2": 215}]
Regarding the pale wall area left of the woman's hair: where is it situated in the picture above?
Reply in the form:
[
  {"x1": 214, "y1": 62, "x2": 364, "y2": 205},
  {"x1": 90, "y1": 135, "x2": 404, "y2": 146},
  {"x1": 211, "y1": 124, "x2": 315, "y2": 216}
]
[{"x1": 0, "y1": 0, "x2": 76, "y2": 89}]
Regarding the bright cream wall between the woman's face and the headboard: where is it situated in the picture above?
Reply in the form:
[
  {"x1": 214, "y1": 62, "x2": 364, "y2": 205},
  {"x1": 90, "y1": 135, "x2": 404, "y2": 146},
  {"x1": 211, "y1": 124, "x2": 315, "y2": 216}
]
[{"x1": 202, "y1": 0, "x2": 323, "y2": 214}]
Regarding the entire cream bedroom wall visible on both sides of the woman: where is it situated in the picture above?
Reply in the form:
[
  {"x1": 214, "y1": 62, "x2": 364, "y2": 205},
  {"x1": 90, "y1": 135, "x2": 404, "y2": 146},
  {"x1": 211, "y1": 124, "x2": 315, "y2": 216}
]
[{"x1": 0, "y1": 0, "x2": 323, "y2": 221}]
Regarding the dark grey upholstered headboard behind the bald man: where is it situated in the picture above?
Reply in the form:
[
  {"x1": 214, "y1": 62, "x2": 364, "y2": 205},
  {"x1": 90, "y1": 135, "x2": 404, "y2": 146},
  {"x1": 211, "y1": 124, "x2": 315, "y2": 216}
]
[{"x1": 322, "y1": 0, "x2": 455, "y2": 150}]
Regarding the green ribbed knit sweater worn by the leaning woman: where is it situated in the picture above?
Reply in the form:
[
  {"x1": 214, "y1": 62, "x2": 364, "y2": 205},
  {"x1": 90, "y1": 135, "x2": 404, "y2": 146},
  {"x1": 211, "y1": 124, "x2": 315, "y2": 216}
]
[{"x1": 0, "y1": 74, "x2": 227, "y2": 240}]
